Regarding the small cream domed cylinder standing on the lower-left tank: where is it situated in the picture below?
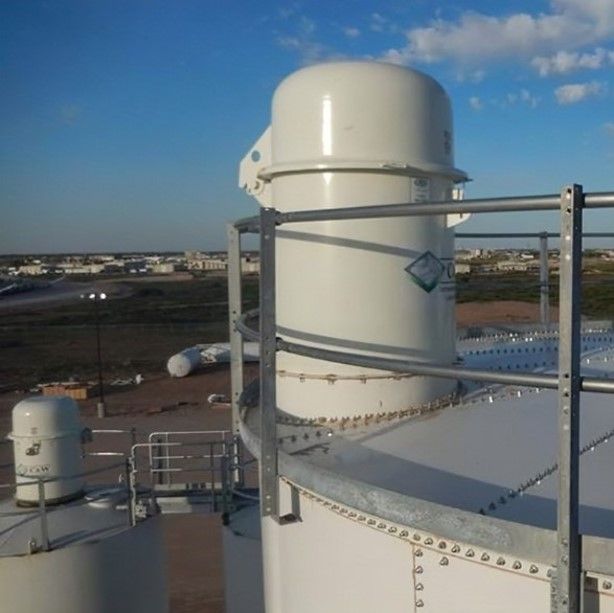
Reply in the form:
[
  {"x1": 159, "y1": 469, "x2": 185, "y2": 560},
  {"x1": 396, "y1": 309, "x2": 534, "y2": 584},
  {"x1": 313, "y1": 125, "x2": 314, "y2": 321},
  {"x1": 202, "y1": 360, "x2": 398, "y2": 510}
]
[{"x1": 9, "y1": 396, "x2": 84, "y2": 505}]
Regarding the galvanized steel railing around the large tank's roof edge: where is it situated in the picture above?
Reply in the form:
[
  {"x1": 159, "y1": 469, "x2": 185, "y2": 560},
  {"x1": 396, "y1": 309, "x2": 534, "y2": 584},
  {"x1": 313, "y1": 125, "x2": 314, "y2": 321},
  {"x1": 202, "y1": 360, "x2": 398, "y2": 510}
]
[{"x1": 228, "y1": 185, "x2": 614, "y2": 613}]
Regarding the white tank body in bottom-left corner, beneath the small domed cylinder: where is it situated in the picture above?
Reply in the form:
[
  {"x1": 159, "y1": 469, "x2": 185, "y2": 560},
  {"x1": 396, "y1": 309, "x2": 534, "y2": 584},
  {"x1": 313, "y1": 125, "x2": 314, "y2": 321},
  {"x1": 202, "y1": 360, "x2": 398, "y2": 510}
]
[{"x1": 0, "y1": 502, "x2": 169, "y2": 613}]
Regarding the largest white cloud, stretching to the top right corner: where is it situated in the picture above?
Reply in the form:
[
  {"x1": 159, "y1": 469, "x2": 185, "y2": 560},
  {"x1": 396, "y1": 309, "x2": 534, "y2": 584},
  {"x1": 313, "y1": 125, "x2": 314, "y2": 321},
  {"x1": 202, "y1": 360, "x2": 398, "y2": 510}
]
[{"x1": 385, "y1": 0, "x2": 614, "y2": 65}]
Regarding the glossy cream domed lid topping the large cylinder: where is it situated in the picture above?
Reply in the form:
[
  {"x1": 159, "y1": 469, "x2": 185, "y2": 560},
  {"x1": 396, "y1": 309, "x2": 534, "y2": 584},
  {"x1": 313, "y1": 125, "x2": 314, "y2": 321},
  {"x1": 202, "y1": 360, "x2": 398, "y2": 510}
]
[{"x1": 268, "y1": 61, "x2": 467, "y2": 181}]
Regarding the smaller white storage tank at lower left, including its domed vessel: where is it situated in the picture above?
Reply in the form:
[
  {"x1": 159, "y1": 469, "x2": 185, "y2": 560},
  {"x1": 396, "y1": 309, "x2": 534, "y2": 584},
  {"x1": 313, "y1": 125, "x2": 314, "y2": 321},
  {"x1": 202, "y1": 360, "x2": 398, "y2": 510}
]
[{"x1": 0, "y1": 397, "x2": 169, "y2": 613}]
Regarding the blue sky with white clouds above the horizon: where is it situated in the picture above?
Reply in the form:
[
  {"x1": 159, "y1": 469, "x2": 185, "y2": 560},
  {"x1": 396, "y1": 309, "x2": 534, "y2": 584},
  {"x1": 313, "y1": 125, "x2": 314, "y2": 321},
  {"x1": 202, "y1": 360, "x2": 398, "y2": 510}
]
[{"x1": 0, "y1": 0, "x2": 614, "y2": 253}]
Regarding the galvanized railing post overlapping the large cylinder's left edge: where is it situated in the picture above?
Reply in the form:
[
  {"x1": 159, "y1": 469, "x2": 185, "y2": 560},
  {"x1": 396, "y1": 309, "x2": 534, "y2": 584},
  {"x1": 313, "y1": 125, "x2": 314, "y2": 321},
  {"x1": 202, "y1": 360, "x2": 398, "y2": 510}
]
[{"x1": 260, "y1": 208, "x2": 279, "y2": 518}]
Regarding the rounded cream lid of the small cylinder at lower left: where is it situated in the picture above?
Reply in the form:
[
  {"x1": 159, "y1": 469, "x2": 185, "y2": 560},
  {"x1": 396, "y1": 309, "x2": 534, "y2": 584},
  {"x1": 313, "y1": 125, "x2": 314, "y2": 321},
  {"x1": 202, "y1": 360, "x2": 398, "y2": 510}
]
[{"x1": 9, "y1": 396, "x2": 83, "y2": 438}]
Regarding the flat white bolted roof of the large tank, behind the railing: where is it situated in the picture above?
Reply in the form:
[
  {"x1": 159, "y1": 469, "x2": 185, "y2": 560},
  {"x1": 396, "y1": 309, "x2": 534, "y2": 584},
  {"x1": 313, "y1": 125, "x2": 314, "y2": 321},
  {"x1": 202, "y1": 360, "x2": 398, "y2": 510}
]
[{"x1": 238, "y1": 330, "x2": 614, "y2": 538}]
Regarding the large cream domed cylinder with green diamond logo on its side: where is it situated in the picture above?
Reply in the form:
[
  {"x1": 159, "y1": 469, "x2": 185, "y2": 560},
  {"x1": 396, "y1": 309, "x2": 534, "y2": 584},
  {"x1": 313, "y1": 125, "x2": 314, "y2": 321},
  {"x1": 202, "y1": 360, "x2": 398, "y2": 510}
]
[{"x1": 241, "y1": 62, "x2": 464, "y2": 418}]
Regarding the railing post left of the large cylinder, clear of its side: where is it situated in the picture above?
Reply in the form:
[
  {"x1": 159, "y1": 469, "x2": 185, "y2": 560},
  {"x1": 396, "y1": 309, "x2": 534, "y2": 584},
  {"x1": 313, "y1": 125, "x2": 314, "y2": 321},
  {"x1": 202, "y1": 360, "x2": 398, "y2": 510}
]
[{"x1": 227, "y1": 224, "x2": 243, "y2": 434}]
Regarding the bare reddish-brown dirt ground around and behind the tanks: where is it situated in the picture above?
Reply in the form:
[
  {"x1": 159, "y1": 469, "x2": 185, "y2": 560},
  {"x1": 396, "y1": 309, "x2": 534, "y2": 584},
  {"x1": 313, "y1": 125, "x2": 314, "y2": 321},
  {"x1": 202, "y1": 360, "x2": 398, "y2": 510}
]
[{"x1": 0, "y1": 302, "x2": 555, "y2": 613}]
